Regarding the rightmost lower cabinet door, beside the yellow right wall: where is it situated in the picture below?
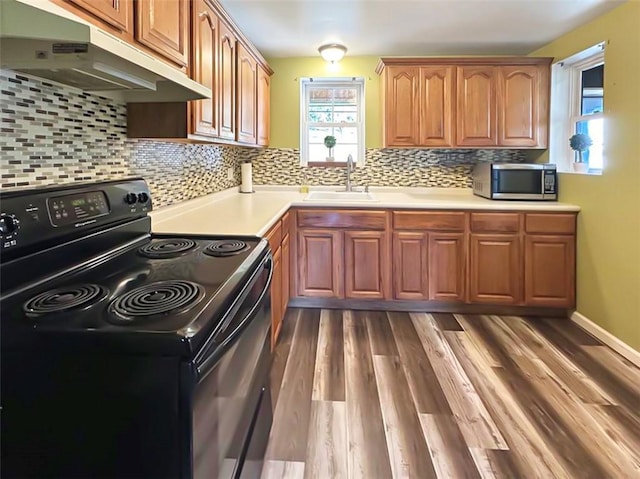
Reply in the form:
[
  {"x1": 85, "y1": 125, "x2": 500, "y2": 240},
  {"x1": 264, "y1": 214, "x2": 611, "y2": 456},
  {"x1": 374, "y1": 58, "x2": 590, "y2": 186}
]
[{"x1": 524, "y1": 235, "x2": 576, "y2": 308}]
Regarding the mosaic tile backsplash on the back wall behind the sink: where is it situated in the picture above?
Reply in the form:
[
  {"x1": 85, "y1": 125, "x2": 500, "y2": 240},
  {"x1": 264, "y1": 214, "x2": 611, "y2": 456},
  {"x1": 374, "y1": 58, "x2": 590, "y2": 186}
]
[{"x1": 247, "y1": 148, "x2": 527, "y2": 188}]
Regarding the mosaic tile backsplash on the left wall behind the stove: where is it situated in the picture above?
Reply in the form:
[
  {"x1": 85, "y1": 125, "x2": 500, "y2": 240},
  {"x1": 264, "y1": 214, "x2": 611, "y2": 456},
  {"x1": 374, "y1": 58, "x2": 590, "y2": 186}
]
[{"x1": 0, "y1": 70, "x2": 241, "y2": 206}]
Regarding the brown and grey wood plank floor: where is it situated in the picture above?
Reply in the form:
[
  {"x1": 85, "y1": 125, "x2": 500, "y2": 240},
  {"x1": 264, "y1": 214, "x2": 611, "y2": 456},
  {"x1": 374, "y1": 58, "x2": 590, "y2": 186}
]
[{"x1": 262, "y1": 309, "x2": 640, "y2": 479}]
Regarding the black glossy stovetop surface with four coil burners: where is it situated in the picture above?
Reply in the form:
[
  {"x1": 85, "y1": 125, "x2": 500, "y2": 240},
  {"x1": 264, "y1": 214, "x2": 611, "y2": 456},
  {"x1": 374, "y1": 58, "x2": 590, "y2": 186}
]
[{"x1": 2, "y1": 236, "x2": 265, "y2": 337}]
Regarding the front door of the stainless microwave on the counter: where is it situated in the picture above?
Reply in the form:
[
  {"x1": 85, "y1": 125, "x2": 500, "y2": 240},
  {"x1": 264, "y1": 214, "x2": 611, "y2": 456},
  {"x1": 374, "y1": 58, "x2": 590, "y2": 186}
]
[{"x1": 491, "y1": 164, "x2": 546, "y2": 200}]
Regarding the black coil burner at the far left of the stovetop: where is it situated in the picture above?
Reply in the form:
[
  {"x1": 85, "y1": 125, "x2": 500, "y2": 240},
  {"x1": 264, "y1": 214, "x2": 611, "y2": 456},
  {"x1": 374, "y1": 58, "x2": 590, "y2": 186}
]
[{"x1": 22, "y1": 284, "x2": 109, "y2": 316}]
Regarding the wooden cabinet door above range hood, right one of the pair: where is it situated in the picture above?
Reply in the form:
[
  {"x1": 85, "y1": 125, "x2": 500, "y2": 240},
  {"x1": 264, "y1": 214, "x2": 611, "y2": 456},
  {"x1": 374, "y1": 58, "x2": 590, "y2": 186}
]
[{"x1": 135, "y1": 0, "x2": 189, "y2": 67}]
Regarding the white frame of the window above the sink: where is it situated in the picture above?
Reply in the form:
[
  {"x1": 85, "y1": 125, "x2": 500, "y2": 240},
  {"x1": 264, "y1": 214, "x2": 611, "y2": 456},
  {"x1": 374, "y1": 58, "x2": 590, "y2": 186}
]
[{"x1": 300, "y1": 77, "x2": 366, "y2": 167}]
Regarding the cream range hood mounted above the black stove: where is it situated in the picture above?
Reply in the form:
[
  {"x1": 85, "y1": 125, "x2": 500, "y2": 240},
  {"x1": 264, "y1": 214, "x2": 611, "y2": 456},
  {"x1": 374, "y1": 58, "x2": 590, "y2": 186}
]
[{"x1": 0, "y1": 0, "x2": 211, "y2": 103}]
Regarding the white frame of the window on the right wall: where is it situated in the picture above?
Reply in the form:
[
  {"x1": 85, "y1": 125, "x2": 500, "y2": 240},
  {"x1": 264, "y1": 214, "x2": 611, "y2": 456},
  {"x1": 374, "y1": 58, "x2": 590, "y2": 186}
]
[{"x1": 549, "y1": 42, "x2": 606, "y2": 175}]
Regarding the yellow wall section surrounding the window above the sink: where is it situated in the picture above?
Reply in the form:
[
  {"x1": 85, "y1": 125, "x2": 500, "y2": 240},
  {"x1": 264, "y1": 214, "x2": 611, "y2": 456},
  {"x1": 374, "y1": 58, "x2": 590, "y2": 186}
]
[{"x1": 268, "y1": 54, "x2": 382, "y2": 148}]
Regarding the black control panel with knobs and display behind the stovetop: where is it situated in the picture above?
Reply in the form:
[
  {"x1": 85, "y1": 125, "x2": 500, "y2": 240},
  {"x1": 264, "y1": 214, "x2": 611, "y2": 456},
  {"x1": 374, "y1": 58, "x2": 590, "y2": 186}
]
[{"x1": 0, "y1": 178, "x2": 151, "y2": 261}]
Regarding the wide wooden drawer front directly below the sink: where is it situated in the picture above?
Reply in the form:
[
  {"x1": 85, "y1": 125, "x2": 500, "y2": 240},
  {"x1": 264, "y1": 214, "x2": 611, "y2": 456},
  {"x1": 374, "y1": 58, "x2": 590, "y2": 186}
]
[{"x1": 298, "y1": 210, "x2": 387, "y2": 230}]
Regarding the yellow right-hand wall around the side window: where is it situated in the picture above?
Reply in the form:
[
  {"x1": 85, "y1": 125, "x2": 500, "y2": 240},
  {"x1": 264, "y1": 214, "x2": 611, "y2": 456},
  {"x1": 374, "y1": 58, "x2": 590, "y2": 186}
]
[{"x1": 532, "y1": 1, "x2": 640, "y2": 350}]
